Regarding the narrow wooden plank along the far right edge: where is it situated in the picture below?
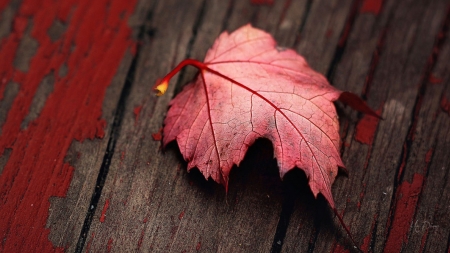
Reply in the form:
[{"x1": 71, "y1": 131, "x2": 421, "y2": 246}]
[{"x1": 400, "y1": 15, "x2": 450, "y2": 252}]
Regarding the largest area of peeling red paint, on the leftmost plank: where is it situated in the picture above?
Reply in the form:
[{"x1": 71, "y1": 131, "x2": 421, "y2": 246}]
[{"x1": 0, "y1": 0, "x2": 136, "y2": 252}]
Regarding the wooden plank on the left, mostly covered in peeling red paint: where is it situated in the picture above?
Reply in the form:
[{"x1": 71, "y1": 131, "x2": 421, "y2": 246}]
[{"x1": 0, "y1": 0, "x2": 151, "y2": 252}]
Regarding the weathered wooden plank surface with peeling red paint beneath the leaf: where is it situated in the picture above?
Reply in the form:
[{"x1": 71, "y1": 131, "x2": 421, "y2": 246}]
[{"x1": 0, "y1": 0, "x2": 450, "y2": 252}]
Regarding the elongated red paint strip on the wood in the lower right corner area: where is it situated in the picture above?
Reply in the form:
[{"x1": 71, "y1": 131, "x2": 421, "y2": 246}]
[{"x1": 384, "y1": 173, "x2": 424, "y2": 252}]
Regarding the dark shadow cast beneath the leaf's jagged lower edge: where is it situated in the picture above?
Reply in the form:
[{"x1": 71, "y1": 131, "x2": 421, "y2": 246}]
[{"x1": 166, "y1": 139, "x2": 352, "y2": 251}]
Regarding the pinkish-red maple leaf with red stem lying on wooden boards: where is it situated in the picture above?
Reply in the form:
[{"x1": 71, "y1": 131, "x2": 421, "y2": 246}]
[{"x1": 155, "y1": 25, "x2": 376, "y2": 247}]
